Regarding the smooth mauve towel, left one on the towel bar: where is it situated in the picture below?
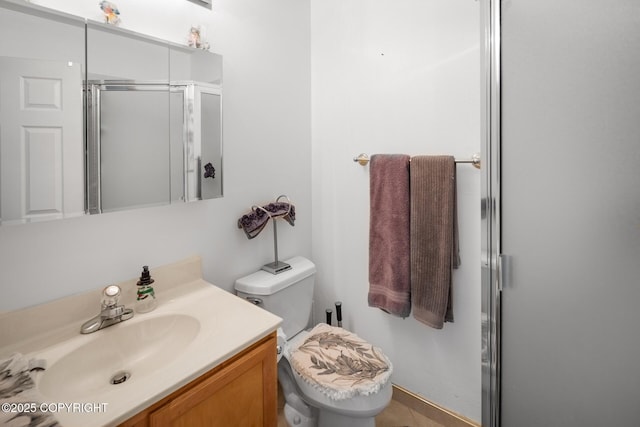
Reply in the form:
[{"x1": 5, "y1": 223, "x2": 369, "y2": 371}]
[{"x1": 368, "y1": 154, "x2": 411, "y2": 317}]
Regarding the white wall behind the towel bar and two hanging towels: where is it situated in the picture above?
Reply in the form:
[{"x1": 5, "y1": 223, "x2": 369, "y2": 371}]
[{"x1": 311, "y1": 0, "x2": 481, "y2": 420}]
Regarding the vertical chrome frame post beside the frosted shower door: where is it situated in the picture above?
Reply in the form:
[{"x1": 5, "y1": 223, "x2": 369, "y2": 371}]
[{"x1": 480, "y1": 0, "x2": 506, "y2": 427}]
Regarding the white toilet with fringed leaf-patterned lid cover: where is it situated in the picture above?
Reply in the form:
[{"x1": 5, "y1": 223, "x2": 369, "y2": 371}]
[{"x1": 235, "y1": 257, "x2": 393, "y2": 427}]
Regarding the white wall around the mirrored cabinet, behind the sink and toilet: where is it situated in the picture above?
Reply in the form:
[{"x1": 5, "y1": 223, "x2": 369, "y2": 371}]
[{"x1": 0, "y1": 0, "x2": 311, "y2": 312}]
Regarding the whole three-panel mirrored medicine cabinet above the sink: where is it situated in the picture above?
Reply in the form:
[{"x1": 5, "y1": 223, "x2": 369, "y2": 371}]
[{"x1": 0, "y1": 0, "x2": 223, "y2": 225}]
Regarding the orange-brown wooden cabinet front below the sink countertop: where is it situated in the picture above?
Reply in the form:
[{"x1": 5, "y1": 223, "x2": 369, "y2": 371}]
[{"x1": 149, "y1": 335, "x2": 277, "y2": 427}]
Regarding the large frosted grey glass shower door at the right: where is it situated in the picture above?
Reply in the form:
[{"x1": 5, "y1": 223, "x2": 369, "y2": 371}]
[{"x1": 501, "y1": 0, "x2": 640, "y2": 427}]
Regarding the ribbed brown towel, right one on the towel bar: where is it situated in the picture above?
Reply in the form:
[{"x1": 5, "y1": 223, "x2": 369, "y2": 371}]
[{"x1": 410, "y1": 156, "x2": 460, "y2": 329}]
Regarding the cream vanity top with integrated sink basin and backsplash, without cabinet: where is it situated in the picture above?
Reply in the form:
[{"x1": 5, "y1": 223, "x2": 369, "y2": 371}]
[{"x1": 0, "y1": 264, "x2": 282, "y2": 427}]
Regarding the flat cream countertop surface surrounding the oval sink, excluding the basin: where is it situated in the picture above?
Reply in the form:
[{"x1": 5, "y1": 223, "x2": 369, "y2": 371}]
[{"x1": 0, "y1": 258, "x2": 282, "y2": 427}]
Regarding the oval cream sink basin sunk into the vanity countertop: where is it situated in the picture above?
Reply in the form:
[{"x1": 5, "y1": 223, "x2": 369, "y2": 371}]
[{"x1": 39, "y1": 314, "x2": 200, "y2": 401}]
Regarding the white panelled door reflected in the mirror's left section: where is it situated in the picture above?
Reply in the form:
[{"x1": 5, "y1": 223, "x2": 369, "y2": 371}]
[{"x1": 0, "y1": 57, "x2": 84, "y2": 224}]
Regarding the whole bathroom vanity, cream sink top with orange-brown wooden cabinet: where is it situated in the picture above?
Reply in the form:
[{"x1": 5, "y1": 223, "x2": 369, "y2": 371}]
[{"x1": 0, "y1": 257, "x2": 281, "y2": 427}]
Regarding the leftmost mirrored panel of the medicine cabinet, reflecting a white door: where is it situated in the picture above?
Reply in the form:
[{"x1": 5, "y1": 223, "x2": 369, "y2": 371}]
[{"x1": 0, "y1": 2, "x2": 85, "y2": 225}]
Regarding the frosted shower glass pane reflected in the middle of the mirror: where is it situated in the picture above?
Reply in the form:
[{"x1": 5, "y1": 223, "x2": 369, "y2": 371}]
[{"x1": 98, "y1": 86, "x2": 171, "y2": 212}]
